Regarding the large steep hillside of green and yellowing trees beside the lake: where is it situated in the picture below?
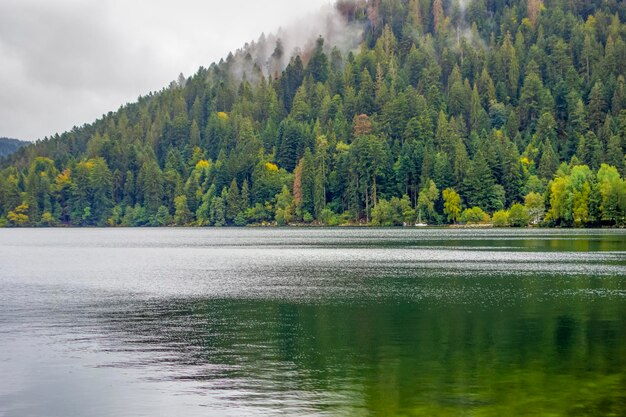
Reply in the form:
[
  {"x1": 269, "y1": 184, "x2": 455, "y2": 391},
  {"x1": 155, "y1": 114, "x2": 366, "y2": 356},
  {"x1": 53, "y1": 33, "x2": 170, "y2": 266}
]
[{"x1": 0, "y1": 0, "x2": 626, "y2": 226}]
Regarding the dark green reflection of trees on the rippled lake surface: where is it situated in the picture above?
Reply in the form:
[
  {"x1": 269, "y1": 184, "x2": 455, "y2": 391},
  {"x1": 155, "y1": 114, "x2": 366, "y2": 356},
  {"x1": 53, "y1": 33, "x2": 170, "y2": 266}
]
[{"x1": 105, "y1": 275, "x2": 626, "y2": 416}]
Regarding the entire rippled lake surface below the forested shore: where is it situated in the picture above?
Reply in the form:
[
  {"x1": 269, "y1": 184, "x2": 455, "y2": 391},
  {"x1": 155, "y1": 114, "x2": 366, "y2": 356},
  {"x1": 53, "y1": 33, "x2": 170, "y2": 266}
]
[{"x1": 0, "y1": 229, "x2": 626, "y2": 417}]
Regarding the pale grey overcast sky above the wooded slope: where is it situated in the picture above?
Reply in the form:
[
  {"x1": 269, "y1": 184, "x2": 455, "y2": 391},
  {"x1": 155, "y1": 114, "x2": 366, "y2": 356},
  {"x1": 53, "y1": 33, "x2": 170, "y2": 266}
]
[{"x1": 0, "y1": 0, "x2": 330, "y2": 140}]
